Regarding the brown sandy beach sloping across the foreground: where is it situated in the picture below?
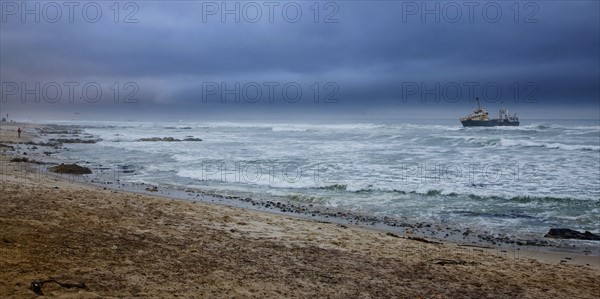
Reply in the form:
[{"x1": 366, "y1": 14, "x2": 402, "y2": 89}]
[{"x1": 0, "y1": 124, "x2": 600, "y2": 298}]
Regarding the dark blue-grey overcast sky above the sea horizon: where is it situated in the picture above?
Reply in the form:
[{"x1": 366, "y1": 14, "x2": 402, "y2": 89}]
[{"x1": 0, "y1": 0, "x2": 600, "y2": 121}]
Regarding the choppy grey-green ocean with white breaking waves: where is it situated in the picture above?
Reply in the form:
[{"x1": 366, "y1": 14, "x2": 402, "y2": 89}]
[{"x1": 47, "y1": 120, "x2": 600, "y2": 241}]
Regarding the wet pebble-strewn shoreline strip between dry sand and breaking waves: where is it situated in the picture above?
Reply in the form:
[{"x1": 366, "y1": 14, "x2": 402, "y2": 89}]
[{"x1": 0, "y1": 123, "x2": 600, "y2": 258}]
